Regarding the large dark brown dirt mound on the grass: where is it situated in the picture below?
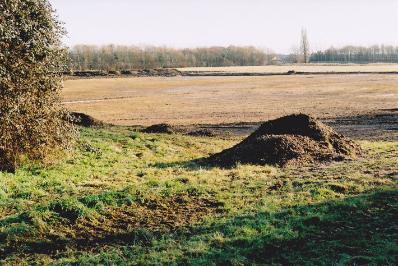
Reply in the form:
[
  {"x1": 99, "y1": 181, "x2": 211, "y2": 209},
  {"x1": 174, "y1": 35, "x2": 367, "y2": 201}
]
[{"x1": 206, "y1": 114, "x2": 361, "y2": 167}]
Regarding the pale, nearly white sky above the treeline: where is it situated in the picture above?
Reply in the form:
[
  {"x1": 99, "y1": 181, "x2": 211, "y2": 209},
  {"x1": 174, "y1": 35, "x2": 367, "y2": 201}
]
[{"x1": 50, "y1": 0, "x2": 398, "y2": 53}]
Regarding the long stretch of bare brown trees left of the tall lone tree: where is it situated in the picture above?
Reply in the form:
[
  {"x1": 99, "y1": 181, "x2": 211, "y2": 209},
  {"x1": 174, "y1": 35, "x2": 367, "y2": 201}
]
[{"x1": 69, "y1": 45, "x2": 275, "y2": 71}]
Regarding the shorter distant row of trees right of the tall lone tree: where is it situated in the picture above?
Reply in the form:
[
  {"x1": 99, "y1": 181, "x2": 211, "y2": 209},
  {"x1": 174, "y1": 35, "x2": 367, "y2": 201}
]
[{"x1": 310, "y1": 45, "x2": 398, "y2": 64}]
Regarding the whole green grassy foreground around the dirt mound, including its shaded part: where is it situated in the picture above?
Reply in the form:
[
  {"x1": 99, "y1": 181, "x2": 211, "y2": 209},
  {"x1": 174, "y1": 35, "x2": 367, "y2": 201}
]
[{"x1": 0, "y1": 127, "x2": 398, "y2": 265}]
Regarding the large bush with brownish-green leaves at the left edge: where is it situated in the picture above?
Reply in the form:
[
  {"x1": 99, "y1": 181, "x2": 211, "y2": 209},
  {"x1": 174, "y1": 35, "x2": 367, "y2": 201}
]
[{"x1": 0, "y1": 0, "x2": 73, "y2": 171}]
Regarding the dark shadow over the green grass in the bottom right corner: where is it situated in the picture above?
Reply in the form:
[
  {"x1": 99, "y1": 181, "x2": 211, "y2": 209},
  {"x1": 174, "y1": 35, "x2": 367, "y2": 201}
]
[{"x1": 178, "y1": 190, "x2": 398, "y2": 265}]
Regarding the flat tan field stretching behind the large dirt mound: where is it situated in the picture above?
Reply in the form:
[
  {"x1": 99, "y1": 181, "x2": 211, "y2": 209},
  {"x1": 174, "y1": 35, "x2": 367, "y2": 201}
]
[{"x1": 63, "y1": 75, "x2": 398, "y2": 125}]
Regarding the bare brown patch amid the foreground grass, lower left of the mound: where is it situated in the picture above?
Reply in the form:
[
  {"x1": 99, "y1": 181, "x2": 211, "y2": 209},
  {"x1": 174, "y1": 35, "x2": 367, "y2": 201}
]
[{"x1": 78, "y1": 195, "x2": 222, "y2": 239}]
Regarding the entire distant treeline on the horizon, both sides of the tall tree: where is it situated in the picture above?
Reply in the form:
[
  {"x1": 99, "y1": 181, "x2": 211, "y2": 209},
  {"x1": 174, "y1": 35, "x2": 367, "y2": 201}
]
[{"x1": 69, "y1": 45, "x2": 398, "y2": 71}]
